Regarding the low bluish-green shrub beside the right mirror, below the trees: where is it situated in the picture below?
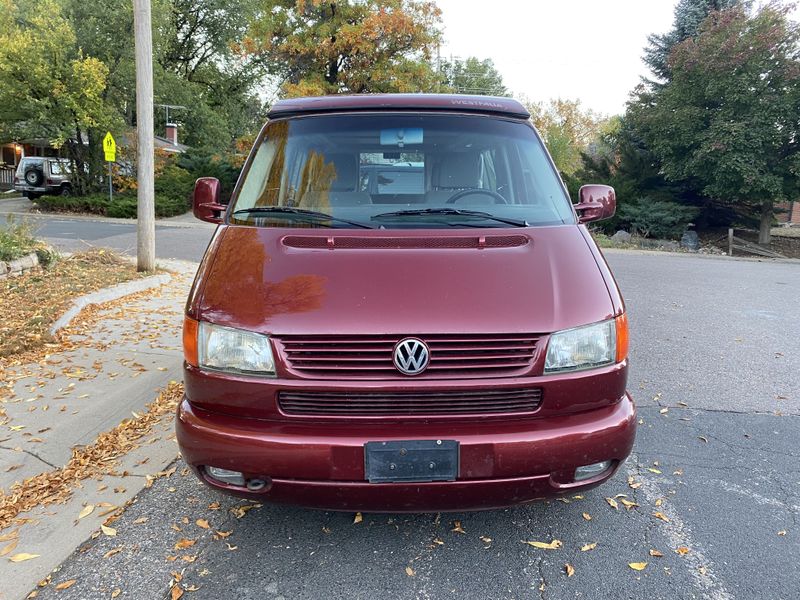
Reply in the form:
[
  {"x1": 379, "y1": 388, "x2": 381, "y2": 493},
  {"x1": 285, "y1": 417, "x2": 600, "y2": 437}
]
[{"x1": 618, "y1": 198, "x2": 700, "y2": 239}]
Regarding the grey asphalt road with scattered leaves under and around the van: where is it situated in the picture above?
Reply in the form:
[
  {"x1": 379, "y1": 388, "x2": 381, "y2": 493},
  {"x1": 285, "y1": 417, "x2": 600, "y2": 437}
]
[{"x1": 23, "y1": 236, "x2": 800, "y2": 600}]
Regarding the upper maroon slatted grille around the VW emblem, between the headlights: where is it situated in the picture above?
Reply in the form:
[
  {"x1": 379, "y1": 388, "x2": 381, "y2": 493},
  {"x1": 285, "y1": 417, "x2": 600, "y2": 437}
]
[{"x1": 277, "y1": 334, "x2": 538, "y2": 379}]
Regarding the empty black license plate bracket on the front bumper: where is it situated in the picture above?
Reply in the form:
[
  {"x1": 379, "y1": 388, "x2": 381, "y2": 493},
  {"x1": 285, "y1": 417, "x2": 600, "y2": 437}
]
[{"x1": 364, "y1": 440, "x2": 459, "y2": 483}]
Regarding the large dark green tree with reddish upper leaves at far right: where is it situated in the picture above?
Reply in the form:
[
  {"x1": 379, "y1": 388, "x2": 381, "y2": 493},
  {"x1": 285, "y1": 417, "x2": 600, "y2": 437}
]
[{"x1": 629, "y1": 4, "x2": 800, "y2": 244}]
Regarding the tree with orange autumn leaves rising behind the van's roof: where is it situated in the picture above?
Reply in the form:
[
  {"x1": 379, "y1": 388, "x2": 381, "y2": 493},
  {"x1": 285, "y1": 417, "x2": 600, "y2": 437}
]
[{"x1": 241, "y1": 0, "x2": 441, "y2": 96}]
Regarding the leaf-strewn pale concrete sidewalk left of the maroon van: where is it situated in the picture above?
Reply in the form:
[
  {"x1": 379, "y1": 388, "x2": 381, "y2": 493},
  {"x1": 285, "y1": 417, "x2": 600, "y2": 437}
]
[{"x1": 0, "y1": 261, "x2": 197, "y2": 600}]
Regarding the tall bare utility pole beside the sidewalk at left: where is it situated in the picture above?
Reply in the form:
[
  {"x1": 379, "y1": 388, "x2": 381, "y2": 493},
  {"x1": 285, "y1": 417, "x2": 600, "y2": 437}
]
[{"x1": 133, "y1": 0, "x2": 156, "y2": 271}]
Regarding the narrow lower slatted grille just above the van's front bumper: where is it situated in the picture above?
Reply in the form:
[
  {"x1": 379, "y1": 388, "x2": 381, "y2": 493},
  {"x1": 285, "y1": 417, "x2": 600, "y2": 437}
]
[{"x1": 278, "y1": 388, "x2": 542, "y2": 416}]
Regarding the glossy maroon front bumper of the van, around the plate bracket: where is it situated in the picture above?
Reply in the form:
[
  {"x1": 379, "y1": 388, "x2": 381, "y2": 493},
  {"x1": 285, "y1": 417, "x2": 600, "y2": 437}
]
[{"x1": 176, "y1": 394, "x2": 636, "y2": 512}]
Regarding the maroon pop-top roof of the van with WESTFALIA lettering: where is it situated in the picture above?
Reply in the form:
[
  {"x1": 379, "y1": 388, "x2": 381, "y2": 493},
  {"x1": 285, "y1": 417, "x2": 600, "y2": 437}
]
[{"x1": 268, "y1": 94, "x2": 530, "y2": 119}]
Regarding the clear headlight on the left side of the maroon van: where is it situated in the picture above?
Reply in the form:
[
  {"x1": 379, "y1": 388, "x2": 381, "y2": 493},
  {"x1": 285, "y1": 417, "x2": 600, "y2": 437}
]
[{"x1": 197, "y1": 321, "x2": 275, "y2": 375}]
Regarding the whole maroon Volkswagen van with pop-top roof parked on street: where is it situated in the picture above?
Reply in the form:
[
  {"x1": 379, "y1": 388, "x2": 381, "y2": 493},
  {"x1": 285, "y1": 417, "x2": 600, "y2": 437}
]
[{"x1": 177, "y1": 94, "x2": 636, "y2": 511}]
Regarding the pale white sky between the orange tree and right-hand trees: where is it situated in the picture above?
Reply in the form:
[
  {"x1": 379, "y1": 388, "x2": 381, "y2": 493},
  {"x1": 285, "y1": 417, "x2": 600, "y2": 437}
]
[{"x1": 436, "y1": 0, "x2": 676, "y2": 115}]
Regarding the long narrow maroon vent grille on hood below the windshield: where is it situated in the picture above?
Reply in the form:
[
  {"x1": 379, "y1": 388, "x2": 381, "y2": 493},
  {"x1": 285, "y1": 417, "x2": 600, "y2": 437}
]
[{"x1": 283, "y1": 235, "x2": 530, "y2": 250}]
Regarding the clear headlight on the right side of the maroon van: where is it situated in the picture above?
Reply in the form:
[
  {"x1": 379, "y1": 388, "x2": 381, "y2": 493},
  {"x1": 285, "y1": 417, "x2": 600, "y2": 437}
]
[{"x1": 544, "y1": 319, "x2": 617, "y2": 373}]
